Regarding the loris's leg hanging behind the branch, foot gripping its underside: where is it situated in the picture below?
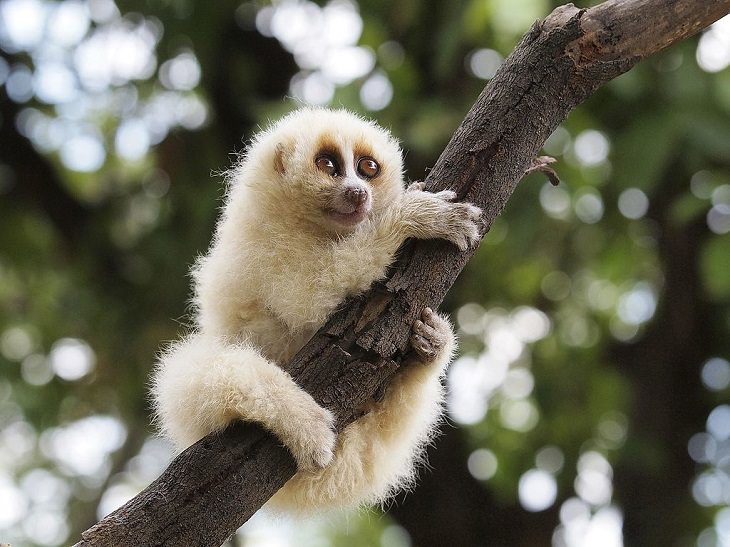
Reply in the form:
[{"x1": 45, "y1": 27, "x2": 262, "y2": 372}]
[{"x1": 269, "y1": 309, "x2": 456, "y2": 511}]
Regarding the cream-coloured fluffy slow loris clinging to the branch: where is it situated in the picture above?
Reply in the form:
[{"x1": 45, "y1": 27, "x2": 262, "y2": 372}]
[{"x1": 153, "y1": 108, "x2": 480, "y2": 513}]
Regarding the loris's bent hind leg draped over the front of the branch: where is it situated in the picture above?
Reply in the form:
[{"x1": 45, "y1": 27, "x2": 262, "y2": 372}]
[{"x1": 152, "y1": 334, "x2": 335, "y2": 469}]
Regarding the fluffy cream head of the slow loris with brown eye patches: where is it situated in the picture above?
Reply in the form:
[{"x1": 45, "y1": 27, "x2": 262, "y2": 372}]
[{"x1": 233, "y1": 108, "x2": 403, "y2": 234}]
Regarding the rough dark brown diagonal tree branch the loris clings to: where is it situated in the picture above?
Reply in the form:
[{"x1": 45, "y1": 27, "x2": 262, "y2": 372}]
[{"x1": 72, "y1": 0, "x2": 730, "y2": 547}]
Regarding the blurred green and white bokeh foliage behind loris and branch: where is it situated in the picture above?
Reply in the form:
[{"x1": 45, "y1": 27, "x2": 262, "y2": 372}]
[{"x1": 0, "y1": 0, "x2": 730, "y2": 547}]
